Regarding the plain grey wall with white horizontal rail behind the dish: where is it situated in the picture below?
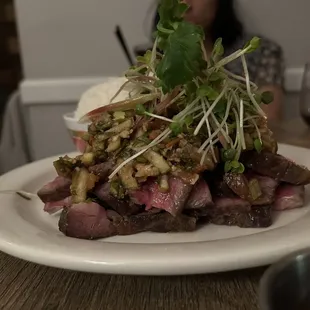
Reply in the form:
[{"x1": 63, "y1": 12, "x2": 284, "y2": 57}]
[{"x1": 0, "y1": 0, "x2": 310, "y2": 168}]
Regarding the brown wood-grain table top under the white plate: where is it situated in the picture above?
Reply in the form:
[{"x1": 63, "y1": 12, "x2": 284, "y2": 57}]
[{"x1": 0, "y1": 120, "x2": 310, "y2": 310}]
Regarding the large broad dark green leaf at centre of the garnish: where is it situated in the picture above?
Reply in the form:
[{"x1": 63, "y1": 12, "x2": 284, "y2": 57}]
[{"x1": 156, "y1": 21, "x2": 204, "y2": 93}]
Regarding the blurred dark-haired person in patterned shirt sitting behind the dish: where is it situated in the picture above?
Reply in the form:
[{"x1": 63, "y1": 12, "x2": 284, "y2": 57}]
[{"x1": 154, "y1": 0, "x2": 285, "y2": 120}]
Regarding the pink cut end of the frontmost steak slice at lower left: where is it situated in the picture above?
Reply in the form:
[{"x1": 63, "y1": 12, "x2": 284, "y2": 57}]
[{"x1": 58, "y1": 202, "x2": 117, "y2": 239}]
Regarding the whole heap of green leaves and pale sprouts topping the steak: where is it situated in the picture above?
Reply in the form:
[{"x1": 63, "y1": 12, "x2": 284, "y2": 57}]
[{"x1": 109, "y1": 0, "x2": 274, "y2": 179}]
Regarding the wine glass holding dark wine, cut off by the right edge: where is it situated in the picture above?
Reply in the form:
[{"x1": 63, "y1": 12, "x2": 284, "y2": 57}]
[{"x1": 299, "y1": 63, "x2": 310, "y2": 126}]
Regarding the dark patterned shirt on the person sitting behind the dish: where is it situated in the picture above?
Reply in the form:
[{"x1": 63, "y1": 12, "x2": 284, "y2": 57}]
[{"x1": 225, "y1": 35, "x2": 285, "y2": 87}]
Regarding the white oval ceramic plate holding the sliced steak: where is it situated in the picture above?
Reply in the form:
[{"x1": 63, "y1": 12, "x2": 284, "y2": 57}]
[{"x1": 0, "y1": 145, "x2": 310, "y2": 275}]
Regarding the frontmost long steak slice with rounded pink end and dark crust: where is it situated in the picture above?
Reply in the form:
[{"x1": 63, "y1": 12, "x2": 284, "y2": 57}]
[{"x1": 59, "y1": 203, "x2": 196, "y2": 239}]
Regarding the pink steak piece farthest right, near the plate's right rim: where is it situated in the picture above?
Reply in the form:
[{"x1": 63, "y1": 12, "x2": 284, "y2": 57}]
[{"x1": 273, "y1": 184, "x2": 305, "y2": 211}]
